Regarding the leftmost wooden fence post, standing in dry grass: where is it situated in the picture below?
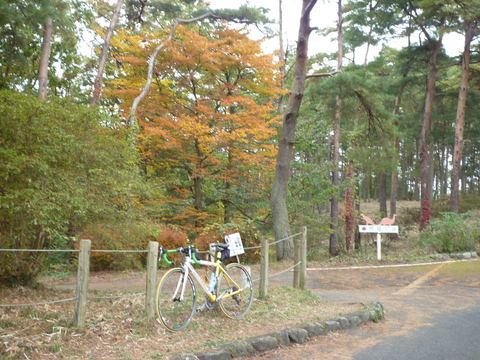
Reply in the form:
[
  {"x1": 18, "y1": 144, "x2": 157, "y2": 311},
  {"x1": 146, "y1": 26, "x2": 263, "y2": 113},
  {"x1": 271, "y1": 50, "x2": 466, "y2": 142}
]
[{"x1": 74, "y1": 240, "x2": 92, "y2": 328}]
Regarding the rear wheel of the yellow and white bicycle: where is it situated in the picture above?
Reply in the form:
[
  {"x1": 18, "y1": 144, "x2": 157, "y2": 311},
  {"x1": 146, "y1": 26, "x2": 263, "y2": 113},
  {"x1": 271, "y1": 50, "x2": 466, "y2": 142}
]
[{"x1": 217, "y1": 264, "x2": 253, "y2": 319}]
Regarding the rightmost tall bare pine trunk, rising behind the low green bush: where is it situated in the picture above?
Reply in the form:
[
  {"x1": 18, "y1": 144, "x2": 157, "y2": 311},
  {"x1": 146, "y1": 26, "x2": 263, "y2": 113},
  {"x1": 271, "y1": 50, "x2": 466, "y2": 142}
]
[{"x1": 450, "y1": 21, "x2": 474, "y2": 212}]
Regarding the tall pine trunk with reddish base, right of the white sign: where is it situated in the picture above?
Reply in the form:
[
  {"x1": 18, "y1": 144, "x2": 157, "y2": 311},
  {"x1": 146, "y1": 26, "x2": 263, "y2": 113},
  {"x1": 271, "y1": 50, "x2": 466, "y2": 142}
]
[{"x1": 418, "y1": 36, "x2": 442, "y2": 231}]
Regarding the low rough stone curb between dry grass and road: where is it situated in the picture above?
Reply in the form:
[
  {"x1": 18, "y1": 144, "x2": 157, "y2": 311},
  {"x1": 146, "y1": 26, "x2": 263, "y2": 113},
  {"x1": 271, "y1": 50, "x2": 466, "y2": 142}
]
[{"x1": 173, "y1": 302, "x2": 385, "y2": 360}]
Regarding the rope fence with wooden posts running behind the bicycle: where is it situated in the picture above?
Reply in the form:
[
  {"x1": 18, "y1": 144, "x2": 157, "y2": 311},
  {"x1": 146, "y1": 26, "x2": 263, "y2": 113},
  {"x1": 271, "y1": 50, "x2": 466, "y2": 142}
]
[{"x1": 0, "y1": 227, "x2": 306, "y2": 327}]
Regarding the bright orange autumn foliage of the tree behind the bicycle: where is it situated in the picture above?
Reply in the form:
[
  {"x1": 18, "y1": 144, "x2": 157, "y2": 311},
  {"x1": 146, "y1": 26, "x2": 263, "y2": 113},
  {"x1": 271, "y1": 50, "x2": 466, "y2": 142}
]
[{"x1": 107, "y1": 27, "x2": 283, "y2": 232}]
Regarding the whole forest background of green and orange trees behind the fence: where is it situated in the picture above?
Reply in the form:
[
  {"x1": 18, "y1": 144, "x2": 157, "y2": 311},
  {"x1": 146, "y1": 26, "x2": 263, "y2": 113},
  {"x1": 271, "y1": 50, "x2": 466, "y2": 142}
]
[{"x1": 0, "y1": 0, "x2": 480, "y2": 283}]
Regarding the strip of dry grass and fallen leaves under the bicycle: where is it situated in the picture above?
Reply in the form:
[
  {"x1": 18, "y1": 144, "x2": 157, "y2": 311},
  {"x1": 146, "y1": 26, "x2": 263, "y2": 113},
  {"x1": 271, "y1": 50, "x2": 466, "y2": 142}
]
[{"x1": 0, "y1": 274, "x2": 362, "y2": 359}]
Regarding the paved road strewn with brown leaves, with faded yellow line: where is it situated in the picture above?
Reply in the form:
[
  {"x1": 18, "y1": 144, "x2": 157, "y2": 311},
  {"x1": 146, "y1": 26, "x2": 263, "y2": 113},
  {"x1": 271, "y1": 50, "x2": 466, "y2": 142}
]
[{"x1": 248, "y1": 261, "x2": 480, "y2": 360}]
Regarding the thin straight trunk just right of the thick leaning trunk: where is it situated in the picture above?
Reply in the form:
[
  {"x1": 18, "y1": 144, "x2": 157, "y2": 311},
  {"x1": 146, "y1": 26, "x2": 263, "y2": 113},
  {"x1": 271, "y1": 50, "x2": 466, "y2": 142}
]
[{"x1": 330, "y1": 0, "x2": 343, "y2": 256}]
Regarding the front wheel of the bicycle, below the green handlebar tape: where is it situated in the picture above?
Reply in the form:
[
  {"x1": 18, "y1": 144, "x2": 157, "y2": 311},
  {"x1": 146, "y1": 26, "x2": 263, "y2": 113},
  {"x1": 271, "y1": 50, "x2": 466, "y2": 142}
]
[{"x1": 155, "y1": 268, "x2": 197, "y2": 331}]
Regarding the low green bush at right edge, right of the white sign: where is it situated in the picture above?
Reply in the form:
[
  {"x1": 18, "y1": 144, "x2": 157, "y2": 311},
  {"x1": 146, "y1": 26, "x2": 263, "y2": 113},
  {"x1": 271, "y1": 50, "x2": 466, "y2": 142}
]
[{"x1": 419, "y1": 211, "x2": 480, "y2": 253}]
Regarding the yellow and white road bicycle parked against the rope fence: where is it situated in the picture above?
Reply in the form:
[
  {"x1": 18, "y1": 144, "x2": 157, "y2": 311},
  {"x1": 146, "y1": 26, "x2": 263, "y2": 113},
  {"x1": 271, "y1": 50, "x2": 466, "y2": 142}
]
[{"x1": 155, "y1": 244, "x2": 253, "y2": 331}]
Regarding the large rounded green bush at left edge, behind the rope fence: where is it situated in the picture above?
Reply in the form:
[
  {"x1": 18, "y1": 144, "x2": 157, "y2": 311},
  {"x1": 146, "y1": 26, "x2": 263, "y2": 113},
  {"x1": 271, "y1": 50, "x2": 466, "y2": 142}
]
[{"x1": 0, "y1": 91, "x2": 139, "y2": 284}]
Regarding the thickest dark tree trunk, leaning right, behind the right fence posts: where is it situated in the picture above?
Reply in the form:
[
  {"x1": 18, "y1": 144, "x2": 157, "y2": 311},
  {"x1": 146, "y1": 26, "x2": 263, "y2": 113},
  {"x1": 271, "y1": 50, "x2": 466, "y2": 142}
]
[{"x1": 271, "y1": 0, "x2": 317, "y2": 260}]
